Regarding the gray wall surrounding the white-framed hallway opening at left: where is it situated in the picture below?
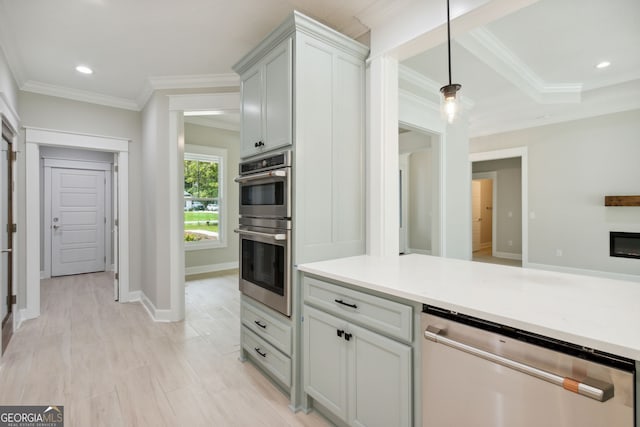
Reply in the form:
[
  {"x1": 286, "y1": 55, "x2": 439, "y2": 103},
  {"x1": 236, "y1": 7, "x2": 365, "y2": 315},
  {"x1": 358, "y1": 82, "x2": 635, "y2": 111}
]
[{"x1": 17, "y1": 91, "x2": 143, "y2": 301}]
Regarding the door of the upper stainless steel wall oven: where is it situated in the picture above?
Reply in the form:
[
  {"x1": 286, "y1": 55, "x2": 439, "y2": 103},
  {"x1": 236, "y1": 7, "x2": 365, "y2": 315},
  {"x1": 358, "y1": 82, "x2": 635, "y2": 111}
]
[{"x1": 236, "y1": 167, "x2": 291, "y2": 218}]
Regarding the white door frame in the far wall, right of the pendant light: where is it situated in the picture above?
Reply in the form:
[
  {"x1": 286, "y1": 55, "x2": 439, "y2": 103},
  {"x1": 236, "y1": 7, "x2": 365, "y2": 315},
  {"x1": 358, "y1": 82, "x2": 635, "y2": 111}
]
[{"x1": 469, "y1": 147, "x2": 529, "y2": 267}]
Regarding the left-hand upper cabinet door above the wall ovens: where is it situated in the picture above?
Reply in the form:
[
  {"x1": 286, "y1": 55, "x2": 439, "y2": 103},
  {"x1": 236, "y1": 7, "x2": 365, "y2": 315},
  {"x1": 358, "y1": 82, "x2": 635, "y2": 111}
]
[{"x1": 240, "y1": 66, "x2": 262, "y2": 155}]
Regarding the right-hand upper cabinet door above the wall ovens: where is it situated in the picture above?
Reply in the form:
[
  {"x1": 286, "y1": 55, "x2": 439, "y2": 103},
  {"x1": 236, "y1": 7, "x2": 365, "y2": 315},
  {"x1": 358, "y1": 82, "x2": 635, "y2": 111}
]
[{"x1": 263, "y1": 39, "x2": 293, "y2": 154}]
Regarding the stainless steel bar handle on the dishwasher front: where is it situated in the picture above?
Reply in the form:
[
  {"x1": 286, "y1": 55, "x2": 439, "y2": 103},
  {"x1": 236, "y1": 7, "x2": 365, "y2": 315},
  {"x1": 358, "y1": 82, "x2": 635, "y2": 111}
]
[{"x1": 424, "y1": 325, "x2": 613, "y2": 402}]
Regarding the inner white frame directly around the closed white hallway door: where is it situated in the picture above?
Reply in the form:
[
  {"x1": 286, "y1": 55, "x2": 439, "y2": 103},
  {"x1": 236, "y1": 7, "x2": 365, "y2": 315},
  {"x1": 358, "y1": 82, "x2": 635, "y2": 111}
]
[{"x1": 40, "y1": 158, "x2": 115, "y2": 279}]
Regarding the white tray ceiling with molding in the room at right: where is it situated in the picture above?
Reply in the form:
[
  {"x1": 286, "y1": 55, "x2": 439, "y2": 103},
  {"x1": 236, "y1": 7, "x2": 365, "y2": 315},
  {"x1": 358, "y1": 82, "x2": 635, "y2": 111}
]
[{"x1": 400, "y1": 0, "x2": 640, "y2": 136}]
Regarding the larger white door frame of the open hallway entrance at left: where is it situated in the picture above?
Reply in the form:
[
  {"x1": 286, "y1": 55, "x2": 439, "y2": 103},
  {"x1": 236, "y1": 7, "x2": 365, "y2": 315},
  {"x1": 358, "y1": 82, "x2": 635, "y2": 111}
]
[{"x1": 25, "y1": 127, "x2": 130, "y2": 321}]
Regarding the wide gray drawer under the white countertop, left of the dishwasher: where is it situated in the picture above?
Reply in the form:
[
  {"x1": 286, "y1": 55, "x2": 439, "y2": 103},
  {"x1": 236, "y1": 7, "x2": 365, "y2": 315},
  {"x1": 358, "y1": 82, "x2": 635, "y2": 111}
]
[{"x1": 303, "y1": 277, "x2": 413, "y2": 342}]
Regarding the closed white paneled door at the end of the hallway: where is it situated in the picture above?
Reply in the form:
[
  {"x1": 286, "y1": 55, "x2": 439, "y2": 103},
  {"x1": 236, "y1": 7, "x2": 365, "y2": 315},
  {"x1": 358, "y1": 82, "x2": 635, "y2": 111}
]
[{"x1": 51, "y1": 168, "x2": 106, "y2": 276}]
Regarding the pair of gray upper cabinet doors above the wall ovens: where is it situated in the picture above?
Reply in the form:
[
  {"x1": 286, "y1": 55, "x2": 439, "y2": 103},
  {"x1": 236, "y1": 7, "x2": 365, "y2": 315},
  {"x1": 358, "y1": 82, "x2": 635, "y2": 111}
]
[{"x1": 240, "y1": 38, "x2": 293, "y2": 158}]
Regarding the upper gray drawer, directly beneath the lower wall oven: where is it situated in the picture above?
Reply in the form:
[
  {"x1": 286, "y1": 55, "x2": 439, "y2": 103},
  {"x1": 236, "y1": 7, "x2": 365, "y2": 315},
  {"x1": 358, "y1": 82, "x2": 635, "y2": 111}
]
[{"x1": 240, "y1": 299, "x2": 291, "y2": 355}]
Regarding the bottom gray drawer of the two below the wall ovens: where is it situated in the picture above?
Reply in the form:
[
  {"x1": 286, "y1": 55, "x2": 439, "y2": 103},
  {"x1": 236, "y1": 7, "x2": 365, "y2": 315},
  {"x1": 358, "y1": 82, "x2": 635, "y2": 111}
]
[{"x1": 240, "y1": 326, "x2": 291, "y2": 387}]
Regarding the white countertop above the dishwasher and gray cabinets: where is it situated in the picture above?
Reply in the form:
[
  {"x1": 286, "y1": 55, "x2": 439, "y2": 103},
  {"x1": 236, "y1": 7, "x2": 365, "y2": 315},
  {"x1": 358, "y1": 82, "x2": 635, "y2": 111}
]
[{"x1": 298, "y1": 255, "x2": 640, "y2": 361}]
